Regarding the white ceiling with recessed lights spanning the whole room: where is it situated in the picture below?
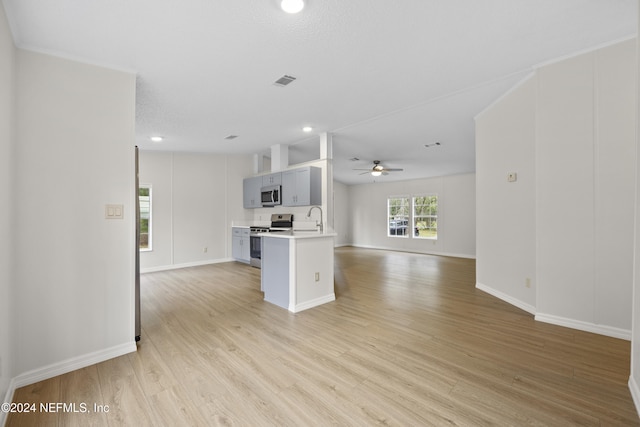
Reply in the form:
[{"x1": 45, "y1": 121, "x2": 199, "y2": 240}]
[{"x1": 3, "y1": 0, "x2": 637, "y2": 184}]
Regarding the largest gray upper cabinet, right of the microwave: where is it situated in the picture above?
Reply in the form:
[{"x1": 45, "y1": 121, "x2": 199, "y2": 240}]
[{"x1": 282, "y1": 166, "x2": 322, "y2": 206}]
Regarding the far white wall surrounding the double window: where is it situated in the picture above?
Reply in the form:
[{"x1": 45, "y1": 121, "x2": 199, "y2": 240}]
[{"x1": 349, "y1": 174, "x2": 476, "y2": 258}]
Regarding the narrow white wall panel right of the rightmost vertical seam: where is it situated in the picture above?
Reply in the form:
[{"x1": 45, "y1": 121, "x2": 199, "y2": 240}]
[{"x1": 593, "y1": 39, "x2": 637, "y2": 330}]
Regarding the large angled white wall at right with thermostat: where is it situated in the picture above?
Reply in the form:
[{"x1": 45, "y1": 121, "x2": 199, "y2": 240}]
[{"x1": 476, "y1": 40, "x2": 636, "y2": 338}]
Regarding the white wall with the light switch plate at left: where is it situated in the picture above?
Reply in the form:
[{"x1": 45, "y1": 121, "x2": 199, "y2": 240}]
[{"x1": 11, "y1": 50, "x2": 135, "y2": 378}]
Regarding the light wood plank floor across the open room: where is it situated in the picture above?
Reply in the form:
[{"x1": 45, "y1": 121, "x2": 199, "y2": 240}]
[{"x1": 7, "y1": 248, "x2": 640, "y2": 426}]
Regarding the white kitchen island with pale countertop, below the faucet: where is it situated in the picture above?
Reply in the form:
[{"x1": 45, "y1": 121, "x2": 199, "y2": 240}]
[{"x1": 261, "y1": 231, "x2": 336, "y2": 313}]
